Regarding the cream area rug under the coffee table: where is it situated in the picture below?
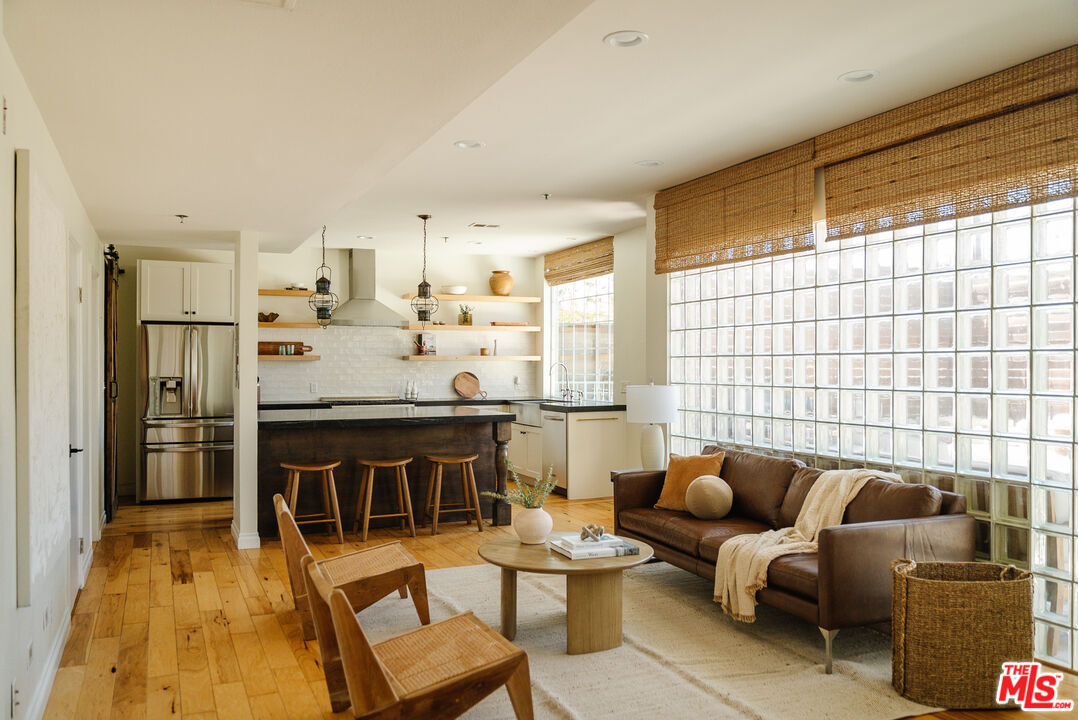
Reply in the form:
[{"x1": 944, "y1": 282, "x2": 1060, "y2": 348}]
[{"x1": 359, "y1": 563, "x2": 937, "y2": 720}]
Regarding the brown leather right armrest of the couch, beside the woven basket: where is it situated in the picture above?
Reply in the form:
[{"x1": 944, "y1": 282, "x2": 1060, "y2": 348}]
[{"x1": 818, "y1": 515, "x2": 975, "y2": 629}]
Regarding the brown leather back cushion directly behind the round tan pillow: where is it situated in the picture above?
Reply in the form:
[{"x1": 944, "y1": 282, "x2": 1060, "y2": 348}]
[{"x1": 720, "y1": 451, "x2": 804, "y2": 528}]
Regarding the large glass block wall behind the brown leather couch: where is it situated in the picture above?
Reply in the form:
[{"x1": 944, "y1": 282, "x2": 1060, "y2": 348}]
[{"x1": 668, "y1": 199, "x2": 1078, "y2": 668}]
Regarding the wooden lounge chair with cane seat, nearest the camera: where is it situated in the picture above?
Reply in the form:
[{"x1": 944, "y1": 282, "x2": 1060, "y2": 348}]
[{"x1": 303, "y1": 558, "x2": 535, "y2": 720}]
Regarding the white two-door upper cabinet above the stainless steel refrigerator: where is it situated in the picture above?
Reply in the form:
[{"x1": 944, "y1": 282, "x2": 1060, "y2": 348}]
[{"x1": 138, "y1": 260, "x2": 235, "y2": 322}]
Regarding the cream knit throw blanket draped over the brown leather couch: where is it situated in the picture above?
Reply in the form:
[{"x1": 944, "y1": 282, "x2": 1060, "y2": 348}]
[{"x1": 715, "y1": 470, "x2": 902, "y2": 623}]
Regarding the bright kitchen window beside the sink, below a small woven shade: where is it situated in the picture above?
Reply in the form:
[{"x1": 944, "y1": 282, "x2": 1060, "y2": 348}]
[{"x1": 550, "y1": 274, "x2": 613, "y2": 400}]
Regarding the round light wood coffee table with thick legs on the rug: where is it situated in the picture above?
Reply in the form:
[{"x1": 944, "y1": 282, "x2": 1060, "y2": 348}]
[{"x1": 479, "y1": 538, "x2": 654, "y2": 655}]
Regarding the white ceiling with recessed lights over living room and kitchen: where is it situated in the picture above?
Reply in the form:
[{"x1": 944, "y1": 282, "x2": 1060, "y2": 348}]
[{"x1": 4, "y1": 0, "x2": 1078, "y2": 254}]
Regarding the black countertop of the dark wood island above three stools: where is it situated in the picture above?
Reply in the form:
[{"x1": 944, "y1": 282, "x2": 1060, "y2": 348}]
[{"x1": 259, "y1": 405, "x2": 516, "y2": 429}]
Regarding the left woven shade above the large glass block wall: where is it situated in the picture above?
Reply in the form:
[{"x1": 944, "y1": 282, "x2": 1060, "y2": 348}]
[{"x1": 655, "y1": 140, "x2": 814, "y2": 274}]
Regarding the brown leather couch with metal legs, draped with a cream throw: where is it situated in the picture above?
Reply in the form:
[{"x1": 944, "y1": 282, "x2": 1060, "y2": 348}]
[{"x1": 611, "y1": 445, "x2": 973, "y2": 673}]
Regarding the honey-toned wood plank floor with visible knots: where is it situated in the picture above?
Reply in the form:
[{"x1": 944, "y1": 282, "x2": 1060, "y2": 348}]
[{"x1": 44, "y1": 497, "x2": 1078, "y2": 720}]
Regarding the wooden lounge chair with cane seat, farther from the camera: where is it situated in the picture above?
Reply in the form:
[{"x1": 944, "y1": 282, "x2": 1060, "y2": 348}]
[{"x1": 273, "y1": 495, "x2": 430, "y2": 640}]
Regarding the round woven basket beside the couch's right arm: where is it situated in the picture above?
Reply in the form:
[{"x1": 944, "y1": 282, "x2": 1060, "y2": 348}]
[{"x1": 890, "y1": 559, "x2": 1033, "y2": 709}]
